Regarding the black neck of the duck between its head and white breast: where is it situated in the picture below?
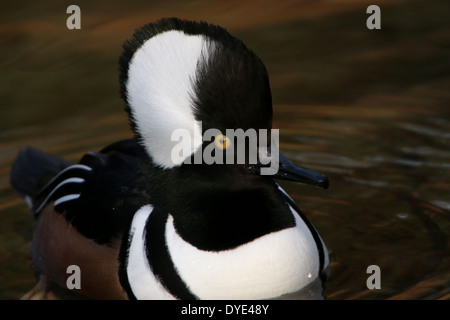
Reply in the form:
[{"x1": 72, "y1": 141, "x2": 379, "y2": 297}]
[{"x1": 145, "y1": 160, "x2": 295, "y2": 251}]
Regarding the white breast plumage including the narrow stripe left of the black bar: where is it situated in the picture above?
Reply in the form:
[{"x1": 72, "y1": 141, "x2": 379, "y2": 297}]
[{"x1": 127, "y1": 205, "x2": 319, "y2": 300}]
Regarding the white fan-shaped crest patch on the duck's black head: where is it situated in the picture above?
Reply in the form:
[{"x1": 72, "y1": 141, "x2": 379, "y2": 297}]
[{"x1": 126, "y1": 30, "x2": 212, "y2": 168}]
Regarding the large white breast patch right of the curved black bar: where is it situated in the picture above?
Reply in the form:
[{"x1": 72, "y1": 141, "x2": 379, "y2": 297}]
[{"x1": 166, "y1": 208, "x2": 319, "y2": 299}]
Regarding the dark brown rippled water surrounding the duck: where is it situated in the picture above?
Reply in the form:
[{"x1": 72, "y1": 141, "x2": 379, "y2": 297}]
[{"x1": 0, "y1": 0, "x2": 450, "y2": 299}]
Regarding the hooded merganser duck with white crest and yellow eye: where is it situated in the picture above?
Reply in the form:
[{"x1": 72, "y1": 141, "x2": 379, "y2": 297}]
[{"x1": 11, "y1": 18, "x2": 329, "y2": 299}]
